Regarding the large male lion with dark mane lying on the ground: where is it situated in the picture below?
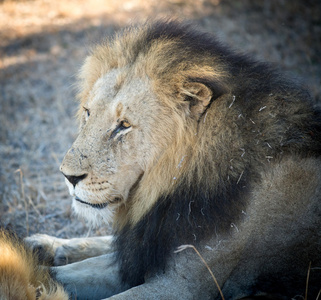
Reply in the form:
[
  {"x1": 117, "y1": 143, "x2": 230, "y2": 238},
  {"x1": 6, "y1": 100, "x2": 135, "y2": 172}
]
[{"x1": 28, "y1": 21, "x2": 321, "y2": 299}]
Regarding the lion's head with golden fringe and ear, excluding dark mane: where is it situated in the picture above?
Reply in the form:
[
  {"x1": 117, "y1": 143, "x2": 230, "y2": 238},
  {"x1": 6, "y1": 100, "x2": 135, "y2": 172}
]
[{"x1": 61, "y1": 21, "x2": 228, "y2": 227}]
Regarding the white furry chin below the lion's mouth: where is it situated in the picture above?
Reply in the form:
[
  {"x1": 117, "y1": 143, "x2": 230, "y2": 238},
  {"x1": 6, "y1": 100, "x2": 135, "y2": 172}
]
[{"x1": 72, "y1": 197, "x2": 113, "y2": 227}]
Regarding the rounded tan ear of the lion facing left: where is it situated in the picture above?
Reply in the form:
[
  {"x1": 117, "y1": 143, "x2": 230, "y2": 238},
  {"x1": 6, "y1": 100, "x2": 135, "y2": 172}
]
[{"x1": 182, "y1": 82, "x2": 213, "y2": 119}]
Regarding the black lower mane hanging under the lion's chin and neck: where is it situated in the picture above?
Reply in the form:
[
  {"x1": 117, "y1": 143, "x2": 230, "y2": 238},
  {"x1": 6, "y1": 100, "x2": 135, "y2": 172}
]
[{"x1": 115, "y1": 168, "x2": 248, "y2": 286}]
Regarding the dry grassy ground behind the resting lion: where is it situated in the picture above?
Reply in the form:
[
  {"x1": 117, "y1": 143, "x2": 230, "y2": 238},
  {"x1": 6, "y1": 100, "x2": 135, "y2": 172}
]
[{"x1": 0, "y1": 0, "x2": 321, "y2": 237}]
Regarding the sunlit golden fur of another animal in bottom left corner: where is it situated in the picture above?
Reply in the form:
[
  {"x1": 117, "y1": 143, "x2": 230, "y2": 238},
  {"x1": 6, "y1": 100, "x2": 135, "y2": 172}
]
[{"x1": 0, "y1": 230, "x2": 68, "y2": 300}]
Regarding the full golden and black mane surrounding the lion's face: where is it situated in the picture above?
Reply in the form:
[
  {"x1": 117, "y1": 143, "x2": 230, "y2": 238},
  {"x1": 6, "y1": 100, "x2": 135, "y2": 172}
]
[{"x1": 80, "y1": 21, "x2": 321, "y2": 286}]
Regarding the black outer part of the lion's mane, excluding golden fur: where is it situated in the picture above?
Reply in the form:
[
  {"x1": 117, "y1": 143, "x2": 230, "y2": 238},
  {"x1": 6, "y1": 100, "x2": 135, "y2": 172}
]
[{"x1": 115, "y1": 21, "x2": 321, "y2": 286}]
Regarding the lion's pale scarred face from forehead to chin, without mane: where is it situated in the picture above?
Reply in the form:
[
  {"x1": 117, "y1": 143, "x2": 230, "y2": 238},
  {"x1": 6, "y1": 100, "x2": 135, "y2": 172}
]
[{"x1": 60, "y1": 70, "x2": 176, "y2": 225}]
